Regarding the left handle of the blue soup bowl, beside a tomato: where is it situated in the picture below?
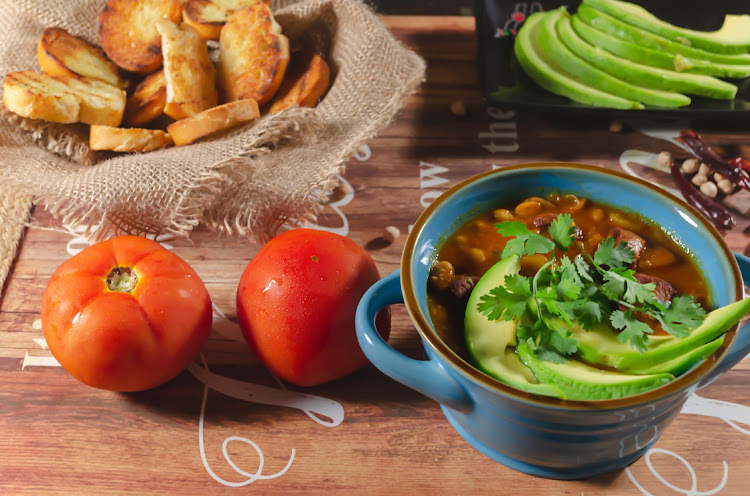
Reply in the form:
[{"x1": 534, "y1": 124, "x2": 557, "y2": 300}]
[{"x1": 356, "y1": 270, "x2": 472, "y2": 412}]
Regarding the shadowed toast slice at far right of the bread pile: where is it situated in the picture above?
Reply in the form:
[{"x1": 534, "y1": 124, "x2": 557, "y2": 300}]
[{"x1": 270, "y1": 50, "x2": 331, "y2": 114}]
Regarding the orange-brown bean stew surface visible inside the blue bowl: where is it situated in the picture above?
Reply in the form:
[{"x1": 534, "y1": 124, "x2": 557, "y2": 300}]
[{"x1": 427, "y1": 194, "x2": 710, "y2": 359}]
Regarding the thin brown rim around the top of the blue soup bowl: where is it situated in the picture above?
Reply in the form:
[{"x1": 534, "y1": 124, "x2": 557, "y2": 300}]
[{"x1": 400, "y1": 162, "x2": 744, "y2": 410}]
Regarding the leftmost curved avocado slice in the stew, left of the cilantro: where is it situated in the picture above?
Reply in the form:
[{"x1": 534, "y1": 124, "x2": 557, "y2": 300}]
[{"x1": 464, "y1": 255, "x2": 565, "y2": 398}]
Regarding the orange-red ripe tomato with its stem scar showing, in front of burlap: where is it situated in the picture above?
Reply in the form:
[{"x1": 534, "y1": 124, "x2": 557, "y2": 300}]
[{"x1": 42, "y1": 236, "x2": 212, "y2": 391}]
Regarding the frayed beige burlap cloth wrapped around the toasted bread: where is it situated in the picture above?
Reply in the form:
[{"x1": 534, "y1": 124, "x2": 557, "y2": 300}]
[{"x1": 0, "y1": 0, "x2": 424, "y2": 290}]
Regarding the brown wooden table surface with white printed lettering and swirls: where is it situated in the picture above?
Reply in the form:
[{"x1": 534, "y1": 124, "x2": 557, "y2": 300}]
[{"x1": 0, "y1": 17, "x2": 750, "y2": 495}]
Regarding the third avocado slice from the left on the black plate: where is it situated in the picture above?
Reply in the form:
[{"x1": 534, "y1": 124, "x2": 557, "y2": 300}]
[{"x1": 560, "y1": 17, "x2": 737, "y2": 100}]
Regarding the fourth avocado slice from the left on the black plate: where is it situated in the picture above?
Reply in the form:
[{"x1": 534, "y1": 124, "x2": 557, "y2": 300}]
[{"x1": 572, "y1": 14, "x2": 750, "y2": 78}]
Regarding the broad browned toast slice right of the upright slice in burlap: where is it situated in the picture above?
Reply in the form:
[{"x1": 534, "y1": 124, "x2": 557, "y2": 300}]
[{"x1": 219, "y1": 2, "x2": 289, "y2": 105}]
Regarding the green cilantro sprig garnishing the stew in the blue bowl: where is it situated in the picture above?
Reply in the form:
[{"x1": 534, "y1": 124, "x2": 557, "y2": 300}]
[{"x1": 478, "y1": 214, "x2": 706, "y2": 361}]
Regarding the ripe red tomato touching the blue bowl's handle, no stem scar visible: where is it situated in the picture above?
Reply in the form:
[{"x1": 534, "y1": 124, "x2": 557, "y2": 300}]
[{"x1": 237, "y1": 229, "x2": 390, "y2": 386}]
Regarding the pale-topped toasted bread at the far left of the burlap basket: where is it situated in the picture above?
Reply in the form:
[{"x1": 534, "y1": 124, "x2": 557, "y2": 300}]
[{"x1": 3, "y1": 71, "x2": 125, "y2": 126}]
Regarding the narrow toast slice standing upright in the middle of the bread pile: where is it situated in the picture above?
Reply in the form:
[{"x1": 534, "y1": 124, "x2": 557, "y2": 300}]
[{"x1": 156, "y1": 19, "x2": 219, "y2": 120}]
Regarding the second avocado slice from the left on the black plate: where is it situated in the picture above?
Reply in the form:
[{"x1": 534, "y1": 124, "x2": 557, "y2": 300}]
[{"x1": 539, "y1": 7, "x2": 690, "y2": 108}]
